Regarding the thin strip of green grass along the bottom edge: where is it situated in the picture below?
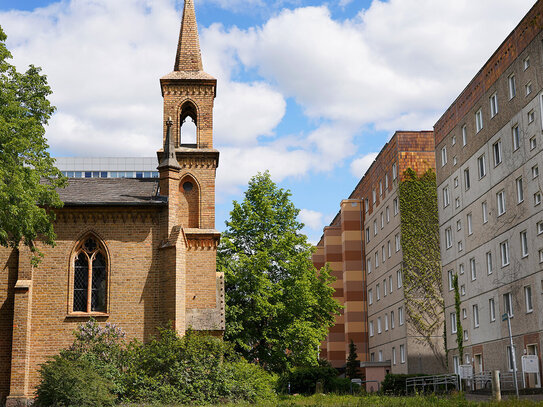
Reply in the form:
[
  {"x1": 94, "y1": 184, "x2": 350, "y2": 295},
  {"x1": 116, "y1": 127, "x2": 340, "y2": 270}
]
[{"x1": 125, "y1": 394, "x2": 543, "y2": 407}]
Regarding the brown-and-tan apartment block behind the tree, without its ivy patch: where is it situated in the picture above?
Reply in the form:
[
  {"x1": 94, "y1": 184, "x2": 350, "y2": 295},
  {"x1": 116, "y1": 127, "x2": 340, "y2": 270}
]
[{"x1": 313, "y1": 131, "x2": 444, "y2": 380}]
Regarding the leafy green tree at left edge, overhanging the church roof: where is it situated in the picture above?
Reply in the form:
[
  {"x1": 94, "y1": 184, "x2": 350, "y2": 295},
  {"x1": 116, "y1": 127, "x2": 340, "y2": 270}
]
[{"x1": 0, "y1": 27, "x2": 65, "y2": 264}]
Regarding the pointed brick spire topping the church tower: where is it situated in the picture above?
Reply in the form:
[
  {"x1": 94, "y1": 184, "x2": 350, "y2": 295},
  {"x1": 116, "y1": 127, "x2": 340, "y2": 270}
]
[{"x1": 173, "y1": 0, "x2": 203, "y2": 72}]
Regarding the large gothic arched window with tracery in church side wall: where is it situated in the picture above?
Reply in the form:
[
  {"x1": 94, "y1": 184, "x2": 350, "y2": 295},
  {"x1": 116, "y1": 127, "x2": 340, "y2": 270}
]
[{"x1": 73, "y1": 236, "x2": 107, "y2": 313}]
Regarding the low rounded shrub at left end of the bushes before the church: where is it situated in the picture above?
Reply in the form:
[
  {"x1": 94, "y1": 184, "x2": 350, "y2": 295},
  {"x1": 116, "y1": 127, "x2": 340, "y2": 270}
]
[{"x1": 36, "y1": 355, "x2": 116, "y2": 407}]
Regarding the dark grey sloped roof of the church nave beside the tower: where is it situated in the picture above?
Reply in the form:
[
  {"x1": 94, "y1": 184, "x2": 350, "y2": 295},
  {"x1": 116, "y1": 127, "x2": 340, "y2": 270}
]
[{"x1": 58, "y1": 178, "x2": 167, "y2": 206}]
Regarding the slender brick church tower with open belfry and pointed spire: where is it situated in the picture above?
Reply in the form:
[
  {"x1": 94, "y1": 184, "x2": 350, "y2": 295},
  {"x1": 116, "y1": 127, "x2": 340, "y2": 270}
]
[{"x1": 158, "y1": 0, "x2": 224, "y2": 334}]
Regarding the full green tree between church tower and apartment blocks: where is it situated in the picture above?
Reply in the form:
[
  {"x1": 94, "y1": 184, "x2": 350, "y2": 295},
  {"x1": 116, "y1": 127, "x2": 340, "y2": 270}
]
[{"x1": 217, "y1": 172, "x2": 340, "y2": 372}]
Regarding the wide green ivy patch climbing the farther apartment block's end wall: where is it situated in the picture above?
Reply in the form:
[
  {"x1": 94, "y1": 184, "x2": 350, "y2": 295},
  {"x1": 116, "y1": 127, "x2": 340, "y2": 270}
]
[{"x1": 398, "y1": 168, "x2": 445, "y2": 365}]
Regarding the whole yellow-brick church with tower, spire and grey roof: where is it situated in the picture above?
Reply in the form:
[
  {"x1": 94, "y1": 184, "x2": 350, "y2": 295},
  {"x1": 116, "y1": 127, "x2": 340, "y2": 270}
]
[{"x1": 0, "y1": 0, "x2": 224, "y2": 406}]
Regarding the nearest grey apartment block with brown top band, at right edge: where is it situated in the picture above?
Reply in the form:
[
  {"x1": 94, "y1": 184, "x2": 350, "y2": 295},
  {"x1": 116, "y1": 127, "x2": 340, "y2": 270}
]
[{"x1": 434, "y1": 1, "x2": 543, "y2": 386}]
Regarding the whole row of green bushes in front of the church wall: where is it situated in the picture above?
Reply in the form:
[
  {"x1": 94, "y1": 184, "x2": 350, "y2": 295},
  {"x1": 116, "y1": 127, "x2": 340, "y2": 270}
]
[{"x1": 36, "y1": 319, "x2": 275, "y2": 407}]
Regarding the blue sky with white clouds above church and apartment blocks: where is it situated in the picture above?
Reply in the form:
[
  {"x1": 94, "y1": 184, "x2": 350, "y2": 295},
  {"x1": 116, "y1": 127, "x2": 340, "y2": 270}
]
[{"x1": 0, "y1": 0, "x2": 534, "y2": 242}]
